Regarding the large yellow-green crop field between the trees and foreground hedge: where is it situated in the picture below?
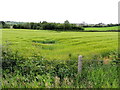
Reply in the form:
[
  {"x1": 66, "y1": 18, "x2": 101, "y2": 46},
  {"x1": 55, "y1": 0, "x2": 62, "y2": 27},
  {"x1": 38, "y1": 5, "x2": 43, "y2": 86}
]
[{"x1": 2, "y1": 29, "x2": 118, "y2": 60}]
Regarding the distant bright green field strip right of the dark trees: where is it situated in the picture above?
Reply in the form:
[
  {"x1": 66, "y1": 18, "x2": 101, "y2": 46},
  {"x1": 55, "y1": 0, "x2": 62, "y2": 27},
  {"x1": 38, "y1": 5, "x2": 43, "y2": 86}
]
[{"x1": 85, "y1": 26, "x2": 120, "y2": 31}]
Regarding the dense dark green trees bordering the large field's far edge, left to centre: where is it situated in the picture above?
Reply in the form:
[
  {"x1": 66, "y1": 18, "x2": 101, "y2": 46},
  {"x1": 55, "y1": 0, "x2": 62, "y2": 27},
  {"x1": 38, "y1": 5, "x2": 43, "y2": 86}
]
[{"x1": 1, "y1": 20, "x2": 84, "y2": 31}]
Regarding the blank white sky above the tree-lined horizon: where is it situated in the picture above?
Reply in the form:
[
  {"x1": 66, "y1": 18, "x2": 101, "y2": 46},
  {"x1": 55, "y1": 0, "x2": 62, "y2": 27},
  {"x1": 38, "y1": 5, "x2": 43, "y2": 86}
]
[{"x1": 0, "y1": 0, "x2": 120, "y2": 24}]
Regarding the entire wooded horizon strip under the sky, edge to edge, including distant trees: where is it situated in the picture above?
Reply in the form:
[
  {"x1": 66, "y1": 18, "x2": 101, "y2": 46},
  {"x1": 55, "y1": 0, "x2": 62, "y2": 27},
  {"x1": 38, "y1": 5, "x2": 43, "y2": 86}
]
[{"x1": 0, "y1": 20, "x2": 120, "y2": 31}]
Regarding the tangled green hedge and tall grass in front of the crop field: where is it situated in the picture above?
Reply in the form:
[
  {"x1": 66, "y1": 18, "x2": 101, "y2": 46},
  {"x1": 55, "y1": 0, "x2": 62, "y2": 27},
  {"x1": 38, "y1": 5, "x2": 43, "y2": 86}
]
[{"x1": 2, "y1": 49, "x2": 119, "y2": 88}]
